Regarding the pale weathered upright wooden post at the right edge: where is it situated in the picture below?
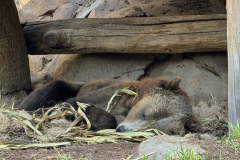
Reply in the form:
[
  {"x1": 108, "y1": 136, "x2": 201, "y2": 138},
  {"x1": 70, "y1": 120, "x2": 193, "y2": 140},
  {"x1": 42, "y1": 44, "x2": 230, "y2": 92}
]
[{"x1": 227, "y1": 0, "x2": 240, "y2": 125}]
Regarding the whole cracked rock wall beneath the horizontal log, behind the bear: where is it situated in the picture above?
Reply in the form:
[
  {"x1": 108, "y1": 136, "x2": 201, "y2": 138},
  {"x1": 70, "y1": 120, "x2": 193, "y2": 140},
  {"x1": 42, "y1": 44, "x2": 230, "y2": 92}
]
[{"x1": 47, "y1": 53, "x2": 228, "y2": 104}]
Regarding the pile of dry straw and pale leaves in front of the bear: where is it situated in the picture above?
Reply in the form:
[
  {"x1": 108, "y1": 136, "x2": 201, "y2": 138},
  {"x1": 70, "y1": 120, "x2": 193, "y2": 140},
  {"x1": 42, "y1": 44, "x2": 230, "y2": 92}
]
[{"x1": 0, "y1": 104, "x2": 160, "y2": 149}]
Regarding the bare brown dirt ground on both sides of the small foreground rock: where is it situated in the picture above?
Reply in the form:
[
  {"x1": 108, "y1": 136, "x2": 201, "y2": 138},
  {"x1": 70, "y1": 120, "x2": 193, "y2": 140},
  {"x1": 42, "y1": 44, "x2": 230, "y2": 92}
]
[{"x1": 0, "y1": 138, "x2": 240, "y2": 160}]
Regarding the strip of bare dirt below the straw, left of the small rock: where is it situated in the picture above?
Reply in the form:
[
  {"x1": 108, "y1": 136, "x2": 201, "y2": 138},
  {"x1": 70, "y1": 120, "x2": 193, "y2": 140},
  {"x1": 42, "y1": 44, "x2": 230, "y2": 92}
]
[{"x1": 0, "y1": 141, "x2": 138, "y2": 160}]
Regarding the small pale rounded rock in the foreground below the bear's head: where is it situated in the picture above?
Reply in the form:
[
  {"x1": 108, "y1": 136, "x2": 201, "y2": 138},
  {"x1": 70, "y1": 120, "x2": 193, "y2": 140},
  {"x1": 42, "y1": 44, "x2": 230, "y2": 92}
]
[{"x1": 131, "y1": 135, "x2": 205, "y2": 160}]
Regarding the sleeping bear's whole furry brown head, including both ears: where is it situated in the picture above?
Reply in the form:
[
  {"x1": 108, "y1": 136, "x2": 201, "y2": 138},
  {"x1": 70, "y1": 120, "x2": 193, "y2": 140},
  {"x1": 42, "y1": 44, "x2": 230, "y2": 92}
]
[{"x1": 114, "y1": 77, "x2": 202, "y2": 135}]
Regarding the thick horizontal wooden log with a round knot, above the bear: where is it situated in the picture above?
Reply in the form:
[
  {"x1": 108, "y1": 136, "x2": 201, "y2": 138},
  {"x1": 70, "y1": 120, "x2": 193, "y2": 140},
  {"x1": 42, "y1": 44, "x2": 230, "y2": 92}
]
[{"x1": 24, "y1": 15, "x2": 227, "y2": 55}]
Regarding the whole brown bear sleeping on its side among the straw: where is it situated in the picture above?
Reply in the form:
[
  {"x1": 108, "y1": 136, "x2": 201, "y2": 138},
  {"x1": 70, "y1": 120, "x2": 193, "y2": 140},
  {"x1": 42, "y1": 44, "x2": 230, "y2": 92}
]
[{"x1": 19, "y1": 77, "x2": 202, "y2": 136}]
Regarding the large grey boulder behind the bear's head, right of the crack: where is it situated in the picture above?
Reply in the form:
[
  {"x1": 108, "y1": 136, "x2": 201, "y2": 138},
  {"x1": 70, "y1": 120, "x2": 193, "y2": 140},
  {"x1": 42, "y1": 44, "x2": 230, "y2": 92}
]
[{"x1": 149, "y1": 53, "x2": 228, "y2": 103}]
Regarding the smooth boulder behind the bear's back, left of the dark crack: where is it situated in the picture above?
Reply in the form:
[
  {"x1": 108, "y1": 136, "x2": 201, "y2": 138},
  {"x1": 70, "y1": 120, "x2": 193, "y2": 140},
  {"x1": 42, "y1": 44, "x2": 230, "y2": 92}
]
[{"x1": 48, "y1": 54, "x2": 154, "y2": 82}]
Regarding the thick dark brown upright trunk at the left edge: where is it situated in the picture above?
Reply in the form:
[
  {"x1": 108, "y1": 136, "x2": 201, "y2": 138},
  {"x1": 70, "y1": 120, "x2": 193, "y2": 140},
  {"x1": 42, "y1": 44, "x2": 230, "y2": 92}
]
[{"x1": 0, "y1": 0, "x2": 31, "y2": 95}]
